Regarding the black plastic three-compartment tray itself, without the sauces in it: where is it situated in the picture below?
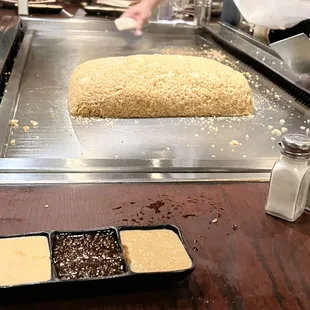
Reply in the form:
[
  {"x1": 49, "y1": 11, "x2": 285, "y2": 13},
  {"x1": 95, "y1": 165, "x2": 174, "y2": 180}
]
[{"x1": 0, "y1": 225, "x2": 195, "y2": 300}]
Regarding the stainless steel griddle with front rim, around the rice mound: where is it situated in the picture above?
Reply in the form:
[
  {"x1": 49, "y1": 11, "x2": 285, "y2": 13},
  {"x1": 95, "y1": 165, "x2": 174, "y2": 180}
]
[{"x1": 0, "y1": 19, "x2": 310, "y2": 183}]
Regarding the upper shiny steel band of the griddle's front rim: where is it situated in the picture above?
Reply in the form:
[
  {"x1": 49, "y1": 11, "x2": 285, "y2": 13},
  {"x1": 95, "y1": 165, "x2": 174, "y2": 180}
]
[{"x1": 0, "y1": 158, "x2": 277, "y2": 173}]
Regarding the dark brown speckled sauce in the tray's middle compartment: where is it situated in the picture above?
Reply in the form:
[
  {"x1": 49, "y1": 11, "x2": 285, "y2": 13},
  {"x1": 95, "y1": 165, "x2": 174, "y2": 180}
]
[{"x1": 53, "y1": 232, "x2": 125, "y2": 279}]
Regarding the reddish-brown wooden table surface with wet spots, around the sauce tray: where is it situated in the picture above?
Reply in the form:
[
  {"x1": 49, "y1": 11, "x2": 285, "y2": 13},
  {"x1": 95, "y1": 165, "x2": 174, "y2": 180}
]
[{"x1": 0, "y1": 183, "x2": 310, "y2": 310}]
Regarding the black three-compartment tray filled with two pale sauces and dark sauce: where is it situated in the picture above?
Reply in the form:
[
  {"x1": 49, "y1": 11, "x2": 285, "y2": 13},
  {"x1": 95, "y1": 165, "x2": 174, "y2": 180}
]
[{"x1": 0, "y1": 225, "x2": 195, "y2": 295}]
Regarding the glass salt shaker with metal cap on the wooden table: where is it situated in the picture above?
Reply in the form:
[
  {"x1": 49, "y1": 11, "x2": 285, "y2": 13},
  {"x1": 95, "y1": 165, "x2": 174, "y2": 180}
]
[{"x1": 265, "y1": 134, "x2": 310, "y2": 222}]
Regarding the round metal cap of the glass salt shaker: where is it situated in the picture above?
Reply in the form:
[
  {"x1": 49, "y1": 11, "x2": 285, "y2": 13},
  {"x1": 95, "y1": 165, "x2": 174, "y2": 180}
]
[{"x1": 279, "y1": 133, "x2": 310, "y2": 158}]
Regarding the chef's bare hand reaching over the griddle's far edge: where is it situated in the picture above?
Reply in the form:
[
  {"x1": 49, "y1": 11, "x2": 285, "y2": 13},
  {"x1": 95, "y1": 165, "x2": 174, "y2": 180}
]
[{"x1": 121, "y1": 0, "x2": 161, "y2": 36}]
